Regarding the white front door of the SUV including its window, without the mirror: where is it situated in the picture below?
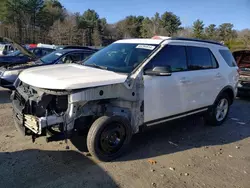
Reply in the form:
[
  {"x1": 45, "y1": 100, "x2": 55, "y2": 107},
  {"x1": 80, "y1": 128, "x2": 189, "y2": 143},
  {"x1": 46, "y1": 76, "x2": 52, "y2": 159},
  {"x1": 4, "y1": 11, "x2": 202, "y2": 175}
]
[{"x1": 144, "y1": 45, "x2": 187, "y2": 122}]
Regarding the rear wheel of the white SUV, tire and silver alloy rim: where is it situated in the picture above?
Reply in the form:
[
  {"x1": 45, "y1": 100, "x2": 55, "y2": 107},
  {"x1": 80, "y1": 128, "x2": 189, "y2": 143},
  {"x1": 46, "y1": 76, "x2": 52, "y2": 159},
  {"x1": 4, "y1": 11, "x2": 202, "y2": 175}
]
[{"x1": 205, "y1": 94, "x2": 230, "y2": 126}]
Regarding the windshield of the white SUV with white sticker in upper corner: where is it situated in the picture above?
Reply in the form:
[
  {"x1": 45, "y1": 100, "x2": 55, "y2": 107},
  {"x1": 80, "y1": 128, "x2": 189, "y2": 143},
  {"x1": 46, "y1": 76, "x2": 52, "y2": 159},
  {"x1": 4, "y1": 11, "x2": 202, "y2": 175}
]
[{"x1": 84, "y1": 43, "x2": 157, "y2": 73}]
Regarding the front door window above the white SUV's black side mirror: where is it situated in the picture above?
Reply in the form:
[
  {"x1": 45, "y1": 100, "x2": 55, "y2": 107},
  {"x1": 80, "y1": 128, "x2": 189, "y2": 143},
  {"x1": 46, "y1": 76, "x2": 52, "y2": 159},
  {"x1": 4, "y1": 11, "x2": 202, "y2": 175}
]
[{"x1": 145, "y1": 45, "x2": 187, "y2": 72}]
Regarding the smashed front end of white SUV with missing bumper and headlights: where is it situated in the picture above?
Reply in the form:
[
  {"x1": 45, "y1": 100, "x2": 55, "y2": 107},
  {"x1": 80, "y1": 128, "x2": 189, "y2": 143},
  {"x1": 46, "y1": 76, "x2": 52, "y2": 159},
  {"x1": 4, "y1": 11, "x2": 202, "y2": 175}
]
[{"x1": 11, "y1": 80, "x2": 68, "y2": 140}]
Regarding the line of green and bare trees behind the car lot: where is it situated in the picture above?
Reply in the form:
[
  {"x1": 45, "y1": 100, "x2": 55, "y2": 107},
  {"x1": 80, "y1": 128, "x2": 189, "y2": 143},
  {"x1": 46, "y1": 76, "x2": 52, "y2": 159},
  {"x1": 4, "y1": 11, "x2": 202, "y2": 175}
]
[{"x1": 0, "y1": 0, "x2": 250, "y2": 50}]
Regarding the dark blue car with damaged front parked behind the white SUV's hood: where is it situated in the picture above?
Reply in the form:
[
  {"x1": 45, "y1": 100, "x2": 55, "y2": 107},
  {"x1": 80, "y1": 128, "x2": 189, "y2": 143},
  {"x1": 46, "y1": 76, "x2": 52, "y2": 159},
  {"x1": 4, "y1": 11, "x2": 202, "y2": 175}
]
[{"x1": 0, "y1": 48, "x2": 95, "y2": 89}]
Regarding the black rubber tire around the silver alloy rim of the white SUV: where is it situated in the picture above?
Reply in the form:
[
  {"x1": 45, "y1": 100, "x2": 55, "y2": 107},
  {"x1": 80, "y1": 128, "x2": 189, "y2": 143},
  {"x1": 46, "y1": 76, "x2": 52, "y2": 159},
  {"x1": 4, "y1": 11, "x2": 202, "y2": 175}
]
[{"x1": 205, "y1": 93, "x2": 231, "y2": 126}]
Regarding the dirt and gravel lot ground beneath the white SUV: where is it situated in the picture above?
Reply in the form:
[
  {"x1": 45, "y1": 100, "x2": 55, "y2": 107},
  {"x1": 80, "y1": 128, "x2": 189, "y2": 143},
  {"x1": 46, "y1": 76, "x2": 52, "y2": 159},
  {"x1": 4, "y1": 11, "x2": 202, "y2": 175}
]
[{"x1": 0, "y1": 89, "x2": 250, "y2": 188}]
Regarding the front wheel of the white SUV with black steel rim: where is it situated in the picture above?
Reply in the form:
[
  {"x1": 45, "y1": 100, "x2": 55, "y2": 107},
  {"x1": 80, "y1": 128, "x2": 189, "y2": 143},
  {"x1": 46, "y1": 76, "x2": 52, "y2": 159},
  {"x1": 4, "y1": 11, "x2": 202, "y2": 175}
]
[{"x1": 87, "y1": 116, "x2": 132, "y2": 161}]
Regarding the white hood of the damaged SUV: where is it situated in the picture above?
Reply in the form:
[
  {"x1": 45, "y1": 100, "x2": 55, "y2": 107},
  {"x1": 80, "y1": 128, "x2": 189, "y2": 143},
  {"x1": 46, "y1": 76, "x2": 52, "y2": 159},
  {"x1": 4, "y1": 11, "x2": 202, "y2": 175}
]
[{"x1": 19, "y1": 64, "x2": 127, "y2": 90}]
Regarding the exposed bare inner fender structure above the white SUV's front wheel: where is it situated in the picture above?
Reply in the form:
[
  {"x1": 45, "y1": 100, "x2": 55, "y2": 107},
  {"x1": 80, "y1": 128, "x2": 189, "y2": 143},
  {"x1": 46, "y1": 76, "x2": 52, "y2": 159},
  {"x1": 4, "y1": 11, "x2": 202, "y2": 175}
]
[{"x1": 68, "y1": 73, "x2": 144, "y2": 133}]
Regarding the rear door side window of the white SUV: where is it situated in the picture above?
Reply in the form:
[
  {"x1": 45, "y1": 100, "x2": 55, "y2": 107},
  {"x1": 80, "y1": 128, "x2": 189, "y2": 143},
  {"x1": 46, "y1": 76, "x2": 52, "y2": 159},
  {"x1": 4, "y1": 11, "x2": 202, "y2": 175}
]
[{"x1": 187, "y1": 46, "x2": 218, "y2": 70}]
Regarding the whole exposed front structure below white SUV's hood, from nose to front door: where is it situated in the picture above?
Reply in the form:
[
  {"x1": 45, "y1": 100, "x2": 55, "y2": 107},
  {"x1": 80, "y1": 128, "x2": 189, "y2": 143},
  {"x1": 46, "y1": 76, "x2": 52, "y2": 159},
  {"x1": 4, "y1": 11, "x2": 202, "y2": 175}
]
[{"x1": 11, "y1": 79, "x2": 143, "y2": 142}]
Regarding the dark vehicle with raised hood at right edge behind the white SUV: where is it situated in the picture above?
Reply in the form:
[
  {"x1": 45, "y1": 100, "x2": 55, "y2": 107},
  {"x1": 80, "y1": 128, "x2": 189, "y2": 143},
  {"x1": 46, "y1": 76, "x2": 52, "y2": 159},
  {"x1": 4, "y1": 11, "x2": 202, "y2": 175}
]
[{"x1": 233, "y1": 50, "x2": 250, "y2": 97}]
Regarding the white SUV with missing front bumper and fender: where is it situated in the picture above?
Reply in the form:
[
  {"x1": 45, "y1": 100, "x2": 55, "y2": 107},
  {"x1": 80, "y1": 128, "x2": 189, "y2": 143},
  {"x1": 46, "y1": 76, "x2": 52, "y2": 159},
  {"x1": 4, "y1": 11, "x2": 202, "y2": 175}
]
[{"x1": 11, "y1": 37, "x2": 239, "y2": 161}]
